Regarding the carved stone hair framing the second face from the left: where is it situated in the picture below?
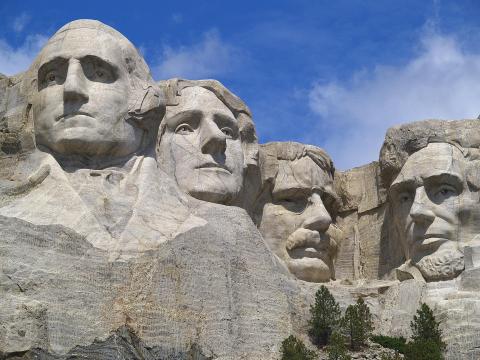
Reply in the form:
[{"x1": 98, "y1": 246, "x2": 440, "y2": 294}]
[{"x1": 157, "y1": 78, "x2": 258, "y2": 167}]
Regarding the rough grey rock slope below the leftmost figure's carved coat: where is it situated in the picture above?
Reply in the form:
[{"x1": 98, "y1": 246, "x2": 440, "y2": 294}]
[{"x1": 0, "y1": 210, "x2": 298, "y2": 359}]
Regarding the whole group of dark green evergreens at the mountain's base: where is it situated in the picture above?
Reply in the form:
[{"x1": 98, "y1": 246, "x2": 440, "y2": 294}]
[{"x1": 281, "y1": 286, "x2": 445, "y2": 360}]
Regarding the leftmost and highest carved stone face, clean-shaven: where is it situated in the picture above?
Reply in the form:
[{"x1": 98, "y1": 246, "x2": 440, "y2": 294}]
[{"x1": 33, "y1": 28, "x2": 143, "y2": 160}]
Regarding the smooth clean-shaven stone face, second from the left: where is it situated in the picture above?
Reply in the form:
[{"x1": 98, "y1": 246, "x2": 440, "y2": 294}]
[{"x1": 158, "y1": 86, "x2": 244, "y2": 204}]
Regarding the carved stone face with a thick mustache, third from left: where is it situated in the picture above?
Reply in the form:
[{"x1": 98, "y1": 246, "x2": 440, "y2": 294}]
[{"x1": 260, "y1": 156, "x2": 337, "y2": 282}]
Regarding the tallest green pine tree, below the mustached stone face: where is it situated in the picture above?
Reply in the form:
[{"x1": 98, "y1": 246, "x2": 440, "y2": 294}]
[{"x1": 309, "y1": 285, "x2": 341, "y2": 346}]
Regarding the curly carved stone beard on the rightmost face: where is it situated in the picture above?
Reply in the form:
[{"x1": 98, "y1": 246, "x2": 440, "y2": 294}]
[{"x1": 412, "y1": 250, "x2": 465, "y2": 281}]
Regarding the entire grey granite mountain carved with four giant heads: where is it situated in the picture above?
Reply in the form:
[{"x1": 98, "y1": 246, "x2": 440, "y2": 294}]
[{"x1": 0, "y1": 20, "x2": 480, "y2": 359}]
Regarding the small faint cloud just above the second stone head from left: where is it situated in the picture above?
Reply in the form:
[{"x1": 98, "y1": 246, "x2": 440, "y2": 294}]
[{"x1": 152, "y1": 30, "x2": 241, "y2": 79}]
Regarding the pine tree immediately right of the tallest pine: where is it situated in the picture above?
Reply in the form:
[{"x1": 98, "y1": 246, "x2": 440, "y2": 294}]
[{"x1": 341, "y1": 297, "x2": 373, "y2": 350}]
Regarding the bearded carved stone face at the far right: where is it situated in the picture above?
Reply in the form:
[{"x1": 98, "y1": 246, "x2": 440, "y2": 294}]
[{"x1": 390, "y1": 143, "x2": 480, "y2": 281}]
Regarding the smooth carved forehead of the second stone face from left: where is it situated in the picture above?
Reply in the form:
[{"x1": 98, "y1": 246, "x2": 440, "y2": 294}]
[{"x1": 167, "y1": 86, "x2": 235, "y2": 119}]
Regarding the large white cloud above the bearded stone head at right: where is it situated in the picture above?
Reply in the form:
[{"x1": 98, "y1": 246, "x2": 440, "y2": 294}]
[{"x1": 306, "y1": 32, "x2": 480, "y2": 169}]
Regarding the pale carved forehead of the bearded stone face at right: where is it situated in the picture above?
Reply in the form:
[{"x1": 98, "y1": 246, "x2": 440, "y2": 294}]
[{"x1": 392, "y1": 143, "x2": 466, "y2": 186}]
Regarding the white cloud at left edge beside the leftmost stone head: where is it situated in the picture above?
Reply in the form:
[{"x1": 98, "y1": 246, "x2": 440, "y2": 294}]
[{"x1": 0, "y1": 34, "x2": 48, "y2": 75}]
